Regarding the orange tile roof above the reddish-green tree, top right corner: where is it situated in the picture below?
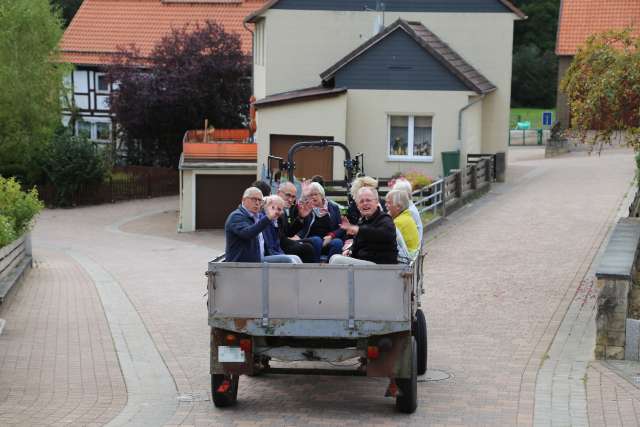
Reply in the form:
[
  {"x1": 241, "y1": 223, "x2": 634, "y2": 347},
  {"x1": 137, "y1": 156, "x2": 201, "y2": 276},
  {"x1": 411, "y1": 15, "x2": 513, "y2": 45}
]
[{"x1": 556, "y1": 0, "x2": 640, "y2": 55}]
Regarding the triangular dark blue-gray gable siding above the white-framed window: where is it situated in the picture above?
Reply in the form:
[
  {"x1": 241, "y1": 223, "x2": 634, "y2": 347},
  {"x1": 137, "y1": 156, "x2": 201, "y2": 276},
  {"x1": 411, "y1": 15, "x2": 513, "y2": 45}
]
[{"x1": 335, "y1": 30, "x2": 471, "y2": 91}]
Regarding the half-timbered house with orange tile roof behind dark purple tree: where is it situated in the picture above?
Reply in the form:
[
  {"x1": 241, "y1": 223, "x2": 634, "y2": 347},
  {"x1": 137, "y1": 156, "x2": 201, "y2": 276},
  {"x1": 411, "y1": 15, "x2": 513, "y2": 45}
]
[{"x1": 59, "y1": 0, "x2": 265, "y2": 142}]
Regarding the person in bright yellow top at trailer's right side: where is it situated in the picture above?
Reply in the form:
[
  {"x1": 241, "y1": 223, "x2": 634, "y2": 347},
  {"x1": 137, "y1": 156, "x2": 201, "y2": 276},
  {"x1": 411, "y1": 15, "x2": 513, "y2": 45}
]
[{"x1": 387, "y1": 190, "x2": 420, "y2": 263}]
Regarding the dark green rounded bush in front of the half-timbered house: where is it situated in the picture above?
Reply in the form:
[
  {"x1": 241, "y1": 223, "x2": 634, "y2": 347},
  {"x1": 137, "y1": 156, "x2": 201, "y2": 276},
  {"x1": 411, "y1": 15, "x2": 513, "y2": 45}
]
[{"x1": 38, "y1": 128, "x2": 107, "y2": 206}]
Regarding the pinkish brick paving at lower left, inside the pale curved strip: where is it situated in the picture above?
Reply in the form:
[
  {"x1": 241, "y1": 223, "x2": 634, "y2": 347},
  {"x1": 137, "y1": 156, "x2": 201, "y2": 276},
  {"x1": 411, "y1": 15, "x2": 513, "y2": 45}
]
[{"x1": 0, "y1": 248, "x2": 127, "y2": 425}]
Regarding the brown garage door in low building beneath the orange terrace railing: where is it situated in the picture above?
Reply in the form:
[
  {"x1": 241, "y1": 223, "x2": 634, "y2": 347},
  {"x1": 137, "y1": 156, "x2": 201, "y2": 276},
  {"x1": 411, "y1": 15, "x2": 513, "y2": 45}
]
[{"x1": 196, "y1": 175, "x2": 256, "y2": 230}]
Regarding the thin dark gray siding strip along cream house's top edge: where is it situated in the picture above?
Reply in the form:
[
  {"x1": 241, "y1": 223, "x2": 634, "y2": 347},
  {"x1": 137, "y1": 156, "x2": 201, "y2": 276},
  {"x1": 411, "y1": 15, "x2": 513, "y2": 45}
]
[{"x1": 272, "y1": 0, "x2": 513, "y2": 13}]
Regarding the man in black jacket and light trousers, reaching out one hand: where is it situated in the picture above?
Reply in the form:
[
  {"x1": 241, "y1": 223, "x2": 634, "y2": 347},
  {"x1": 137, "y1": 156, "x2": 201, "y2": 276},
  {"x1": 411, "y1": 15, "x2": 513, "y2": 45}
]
[{"x1": 329, "y1": 187, "x2": 398, "y2": 264}]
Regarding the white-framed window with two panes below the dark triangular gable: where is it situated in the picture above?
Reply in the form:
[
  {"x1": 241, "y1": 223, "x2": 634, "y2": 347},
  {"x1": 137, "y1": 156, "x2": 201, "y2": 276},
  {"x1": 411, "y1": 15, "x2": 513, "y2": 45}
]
[{"x1": 389, "y1": 115, "x2": 433, "y2": 160}]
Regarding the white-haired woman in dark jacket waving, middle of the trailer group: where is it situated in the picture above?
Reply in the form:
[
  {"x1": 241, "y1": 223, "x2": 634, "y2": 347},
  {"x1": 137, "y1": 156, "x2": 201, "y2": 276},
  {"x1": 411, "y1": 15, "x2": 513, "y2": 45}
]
[{"x1": 297, "y1": 182, "x2": 344, "y2": 258}]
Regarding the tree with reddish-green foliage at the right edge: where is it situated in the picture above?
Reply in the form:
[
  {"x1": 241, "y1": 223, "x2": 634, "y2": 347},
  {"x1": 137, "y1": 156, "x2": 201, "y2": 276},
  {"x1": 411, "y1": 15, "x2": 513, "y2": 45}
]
[{"x1": 560, "y1": 29, "x2": 640, "y2": 151}]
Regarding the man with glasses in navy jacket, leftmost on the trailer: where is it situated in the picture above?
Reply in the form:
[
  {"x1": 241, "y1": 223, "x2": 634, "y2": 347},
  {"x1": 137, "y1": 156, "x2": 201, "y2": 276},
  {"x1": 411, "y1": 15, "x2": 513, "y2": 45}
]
[{"x1": 224, "y1": 187, "x2": 292, "y2": 263}]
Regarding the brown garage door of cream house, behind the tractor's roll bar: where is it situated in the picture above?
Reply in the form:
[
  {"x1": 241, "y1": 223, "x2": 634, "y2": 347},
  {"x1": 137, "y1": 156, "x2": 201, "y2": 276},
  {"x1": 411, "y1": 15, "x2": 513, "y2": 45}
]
[{"x1": 271, "y1": 135, "x2": 333, "y2": 181}]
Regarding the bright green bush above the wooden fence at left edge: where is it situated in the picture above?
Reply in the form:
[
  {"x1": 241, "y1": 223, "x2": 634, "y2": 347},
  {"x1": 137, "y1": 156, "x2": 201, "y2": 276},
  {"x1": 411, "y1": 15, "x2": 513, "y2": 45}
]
[{"x1": 0, "y1": 177, "x2": 43, "y2": 246}]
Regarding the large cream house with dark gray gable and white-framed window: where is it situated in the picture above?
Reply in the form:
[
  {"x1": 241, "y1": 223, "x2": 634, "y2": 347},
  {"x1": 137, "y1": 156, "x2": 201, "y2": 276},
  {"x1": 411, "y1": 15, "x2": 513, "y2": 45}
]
[{"x1": 245, "y1": 0, "x2": 526, "y2": 179}]
